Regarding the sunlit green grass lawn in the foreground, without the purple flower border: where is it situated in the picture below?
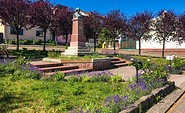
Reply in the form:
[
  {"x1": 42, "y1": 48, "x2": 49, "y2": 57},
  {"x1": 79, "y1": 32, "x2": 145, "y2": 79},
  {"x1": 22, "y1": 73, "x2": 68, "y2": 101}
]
[{"x1": 0, "y1": 76, "x2": 126, "y2": 113}]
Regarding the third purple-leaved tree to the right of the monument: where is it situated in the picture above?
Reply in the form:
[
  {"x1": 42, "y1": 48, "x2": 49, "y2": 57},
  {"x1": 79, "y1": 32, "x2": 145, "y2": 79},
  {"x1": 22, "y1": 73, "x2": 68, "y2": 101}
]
[{"x1": 129, "y1": 11, "x2": 152, "y2": 55}]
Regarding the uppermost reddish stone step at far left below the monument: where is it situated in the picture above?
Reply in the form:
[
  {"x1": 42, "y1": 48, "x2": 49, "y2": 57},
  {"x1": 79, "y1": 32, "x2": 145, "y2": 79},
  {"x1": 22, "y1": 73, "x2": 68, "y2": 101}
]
[{"x1": 30, "y1": 61, "x2": 63, "y2": 68}]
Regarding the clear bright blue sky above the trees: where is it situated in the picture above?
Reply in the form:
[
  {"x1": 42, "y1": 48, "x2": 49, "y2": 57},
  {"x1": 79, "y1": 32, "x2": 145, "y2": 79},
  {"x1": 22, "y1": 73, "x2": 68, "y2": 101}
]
[{"x1": 51, "y1": 0, "x2": 185, "y2": 16}]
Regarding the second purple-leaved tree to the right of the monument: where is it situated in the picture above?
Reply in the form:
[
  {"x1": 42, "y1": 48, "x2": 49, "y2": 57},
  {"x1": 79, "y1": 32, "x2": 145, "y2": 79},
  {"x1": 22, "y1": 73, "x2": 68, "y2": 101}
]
[{"x1": 104, "y1": 10, "x2": 127, "y2": 50}]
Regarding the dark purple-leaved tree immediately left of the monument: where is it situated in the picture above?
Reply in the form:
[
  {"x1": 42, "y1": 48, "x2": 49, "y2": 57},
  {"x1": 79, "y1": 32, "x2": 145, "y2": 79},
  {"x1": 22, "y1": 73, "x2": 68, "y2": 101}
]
[{"x1": 50, "y1": 5, "x2": 73, "y2": 44}]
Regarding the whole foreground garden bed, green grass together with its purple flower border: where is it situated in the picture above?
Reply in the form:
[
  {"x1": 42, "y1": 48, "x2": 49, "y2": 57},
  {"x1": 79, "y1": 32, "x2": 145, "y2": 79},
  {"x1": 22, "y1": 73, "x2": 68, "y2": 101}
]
[{"x1": 0, "y1": 58, "x2": 172, "y2": 113}]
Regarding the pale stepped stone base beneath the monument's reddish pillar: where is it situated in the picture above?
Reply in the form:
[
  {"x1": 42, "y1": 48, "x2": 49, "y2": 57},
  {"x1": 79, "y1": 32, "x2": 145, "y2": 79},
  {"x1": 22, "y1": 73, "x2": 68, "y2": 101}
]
[{"x1": 61, "y1": 47, "x2": 92, "y2": 56}]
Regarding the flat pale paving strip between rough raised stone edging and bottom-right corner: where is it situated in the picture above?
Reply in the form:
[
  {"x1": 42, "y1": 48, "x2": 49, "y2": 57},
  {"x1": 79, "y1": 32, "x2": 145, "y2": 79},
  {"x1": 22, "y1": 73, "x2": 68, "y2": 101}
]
[{"x1": 147, "y1": 82, "x2": 185, "y2": 113}]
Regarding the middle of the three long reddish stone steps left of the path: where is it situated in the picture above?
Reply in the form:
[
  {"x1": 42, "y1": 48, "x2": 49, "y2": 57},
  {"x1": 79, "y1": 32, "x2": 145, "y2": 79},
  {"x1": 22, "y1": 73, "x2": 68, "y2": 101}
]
[{"x1": 39, "y1": 66, "x2": 79, "y2": 72}]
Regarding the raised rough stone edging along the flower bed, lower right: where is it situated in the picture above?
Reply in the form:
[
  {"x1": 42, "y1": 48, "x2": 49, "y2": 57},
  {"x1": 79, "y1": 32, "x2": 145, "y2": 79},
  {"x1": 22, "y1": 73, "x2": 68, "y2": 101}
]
[{"x1": 120, "y1": 82, "x2": 175, "y2": 113}]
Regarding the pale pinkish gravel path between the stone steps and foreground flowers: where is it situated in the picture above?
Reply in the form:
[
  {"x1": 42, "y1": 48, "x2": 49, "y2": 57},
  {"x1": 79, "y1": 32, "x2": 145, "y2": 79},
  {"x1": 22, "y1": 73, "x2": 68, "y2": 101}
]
[{"x1": 108, "y1": 66, "x2": 136, "y2": 80}]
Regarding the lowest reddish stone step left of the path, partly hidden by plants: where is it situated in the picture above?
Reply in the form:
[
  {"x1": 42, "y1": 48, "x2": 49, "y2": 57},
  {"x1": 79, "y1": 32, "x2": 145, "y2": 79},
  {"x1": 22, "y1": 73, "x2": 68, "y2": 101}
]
[{"x1": 45, "y1": 68, "x2": 93, "y2": 76}]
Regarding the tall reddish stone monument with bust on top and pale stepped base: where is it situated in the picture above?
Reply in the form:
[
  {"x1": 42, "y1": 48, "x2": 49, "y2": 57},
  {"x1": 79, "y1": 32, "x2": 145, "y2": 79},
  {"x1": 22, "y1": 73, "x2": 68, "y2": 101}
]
[{"x1": 62, "y1": 8, "x2": 91, "y2": 55}]
